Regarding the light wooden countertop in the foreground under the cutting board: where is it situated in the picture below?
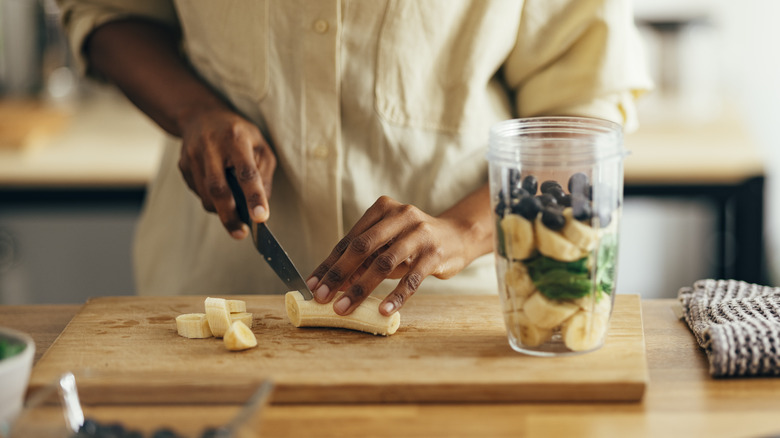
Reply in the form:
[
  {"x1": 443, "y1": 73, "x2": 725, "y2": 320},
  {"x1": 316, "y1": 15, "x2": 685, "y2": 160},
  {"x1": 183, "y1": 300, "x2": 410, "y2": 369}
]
[{"x1": 0, "y1": 299, "x2": 780, "y2": 437}]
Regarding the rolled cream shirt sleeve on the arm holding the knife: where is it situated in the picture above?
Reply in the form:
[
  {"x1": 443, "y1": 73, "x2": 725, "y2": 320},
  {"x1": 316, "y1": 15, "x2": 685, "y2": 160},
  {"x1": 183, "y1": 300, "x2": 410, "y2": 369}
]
[{"x1": 57, "y1": 0, "x2": 179, "y2": 75}]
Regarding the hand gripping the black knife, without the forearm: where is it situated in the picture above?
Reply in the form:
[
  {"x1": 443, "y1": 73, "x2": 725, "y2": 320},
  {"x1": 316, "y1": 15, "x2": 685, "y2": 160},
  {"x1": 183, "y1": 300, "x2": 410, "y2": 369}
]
[{"x1": 178, "y1": 105, "x2": 276, "y2": 239}]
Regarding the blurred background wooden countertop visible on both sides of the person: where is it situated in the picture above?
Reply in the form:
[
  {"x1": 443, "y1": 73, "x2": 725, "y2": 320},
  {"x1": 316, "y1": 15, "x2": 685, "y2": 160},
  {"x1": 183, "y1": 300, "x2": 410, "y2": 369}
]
[{"x1": 0, "y1": 89, "x2": 764, "y2": 188}]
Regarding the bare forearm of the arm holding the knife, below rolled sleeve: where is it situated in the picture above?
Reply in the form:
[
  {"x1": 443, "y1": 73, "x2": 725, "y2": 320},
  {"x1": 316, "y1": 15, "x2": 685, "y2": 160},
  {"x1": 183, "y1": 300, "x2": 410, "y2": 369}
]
[{"x1": 84, "y1": 18, "x2": 229, "y2": 137}]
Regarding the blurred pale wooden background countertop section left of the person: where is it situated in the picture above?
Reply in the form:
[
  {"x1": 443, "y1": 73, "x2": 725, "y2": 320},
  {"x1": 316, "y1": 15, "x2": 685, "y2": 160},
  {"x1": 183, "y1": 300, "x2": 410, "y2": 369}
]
[{"x1": 0, "y1": 89, "x2": 164, "y2": 188}]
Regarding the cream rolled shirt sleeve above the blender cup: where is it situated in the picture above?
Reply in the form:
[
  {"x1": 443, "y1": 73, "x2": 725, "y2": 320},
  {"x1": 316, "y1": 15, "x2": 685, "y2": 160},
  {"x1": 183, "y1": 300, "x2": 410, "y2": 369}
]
[{"x1": 504, "y1": 0, "x2": 653, "y2": 131}]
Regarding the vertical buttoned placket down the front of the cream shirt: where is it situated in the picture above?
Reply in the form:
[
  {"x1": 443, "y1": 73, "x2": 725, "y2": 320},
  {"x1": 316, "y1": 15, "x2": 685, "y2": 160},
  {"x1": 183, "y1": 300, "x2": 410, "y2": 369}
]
[{"x1": 300, "y1": 0, "x2": 343, "y2": 245}]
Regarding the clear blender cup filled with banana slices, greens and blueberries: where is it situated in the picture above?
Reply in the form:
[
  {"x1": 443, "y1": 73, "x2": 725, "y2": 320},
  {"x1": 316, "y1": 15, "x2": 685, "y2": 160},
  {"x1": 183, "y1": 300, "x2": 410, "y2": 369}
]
[{"x1": 487, "y1": 117, "x2": 625, "y2": 356}]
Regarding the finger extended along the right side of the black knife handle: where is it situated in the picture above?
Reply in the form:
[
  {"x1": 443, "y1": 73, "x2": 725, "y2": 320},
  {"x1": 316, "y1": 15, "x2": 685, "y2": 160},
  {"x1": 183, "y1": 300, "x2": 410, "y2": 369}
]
[{"x1": 231, "y1": 139, "x2": 269, "y2": 222}]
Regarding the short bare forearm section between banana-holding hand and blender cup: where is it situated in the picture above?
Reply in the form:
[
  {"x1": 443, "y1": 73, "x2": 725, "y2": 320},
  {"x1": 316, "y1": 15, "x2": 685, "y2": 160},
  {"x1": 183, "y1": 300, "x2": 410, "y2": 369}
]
[{"x1": 439, "y1": 183, "x2": 495, "y2": 264}]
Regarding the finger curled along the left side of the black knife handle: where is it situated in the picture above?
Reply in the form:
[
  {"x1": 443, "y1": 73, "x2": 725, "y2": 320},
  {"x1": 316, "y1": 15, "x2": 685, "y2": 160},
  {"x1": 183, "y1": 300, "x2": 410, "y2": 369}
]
[{"x1": 202, "y1": 148, "x2": 246, "y2": 239}]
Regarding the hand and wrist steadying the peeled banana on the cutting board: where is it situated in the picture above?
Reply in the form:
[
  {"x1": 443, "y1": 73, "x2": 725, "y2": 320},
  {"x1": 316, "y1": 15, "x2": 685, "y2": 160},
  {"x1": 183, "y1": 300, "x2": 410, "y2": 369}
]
[{"x1": 307, "y1": 185, "x2": 493, "y2": 315}]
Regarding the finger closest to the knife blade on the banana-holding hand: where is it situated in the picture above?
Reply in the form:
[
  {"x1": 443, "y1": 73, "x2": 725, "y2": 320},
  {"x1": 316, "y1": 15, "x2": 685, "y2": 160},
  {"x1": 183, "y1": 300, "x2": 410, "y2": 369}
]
[{"x1": 306, "y1": 196, "x2": 393, "y2": 303}]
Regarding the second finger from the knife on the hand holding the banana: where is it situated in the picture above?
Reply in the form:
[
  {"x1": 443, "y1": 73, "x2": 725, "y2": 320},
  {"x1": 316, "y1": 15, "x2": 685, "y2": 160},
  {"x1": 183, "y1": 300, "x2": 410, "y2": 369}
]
[{"x1": 315, "y1": 216, "x2": 406, "y2": 302}]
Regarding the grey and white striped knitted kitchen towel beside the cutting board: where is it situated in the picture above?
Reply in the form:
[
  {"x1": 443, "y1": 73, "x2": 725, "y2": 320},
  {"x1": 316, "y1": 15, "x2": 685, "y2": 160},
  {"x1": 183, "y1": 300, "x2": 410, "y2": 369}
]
[{"x1": 678, "y1": 279, "x2": 780, "y2": 377}]
